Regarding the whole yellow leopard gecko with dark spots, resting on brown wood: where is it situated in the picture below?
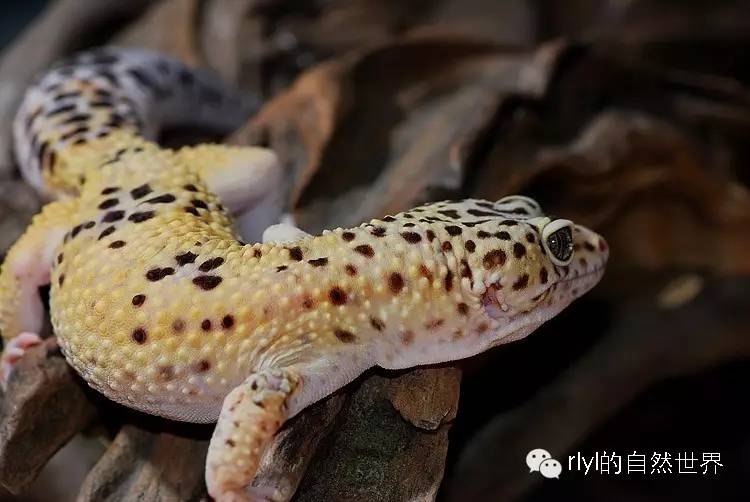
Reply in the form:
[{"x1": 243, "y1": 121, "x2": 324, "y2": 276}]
[{"x1": 0, "y1": 51, "x2": 608, "y2": 500}]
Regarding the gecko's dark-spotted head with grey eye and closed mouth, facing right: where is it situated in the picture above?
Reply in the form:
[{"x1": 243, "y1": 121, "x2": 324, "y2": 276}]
[{"x1": 479, "y1": 196, "x2": 609, "y2": 343}]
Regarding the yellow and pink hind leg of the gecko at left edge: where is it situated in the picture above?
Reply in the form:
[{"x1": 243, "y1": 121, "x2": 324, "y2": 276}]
[{"x1": 0, "y1": 201, "x2": 75, "y2": 387}]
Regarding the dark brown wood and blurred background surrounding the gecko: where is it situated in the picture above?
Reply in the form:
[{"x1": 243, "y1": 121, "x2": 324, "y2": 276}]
[{"x1": 0, "y1": 0, "x2": 750, "y2": 501}]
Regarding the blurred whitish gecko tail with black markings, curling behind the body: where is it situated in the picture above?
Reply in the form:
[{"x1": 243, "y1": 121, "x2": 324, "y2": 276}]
[{"x1": 13, "y1": 47, "x2": 259, "y2": 196}]
